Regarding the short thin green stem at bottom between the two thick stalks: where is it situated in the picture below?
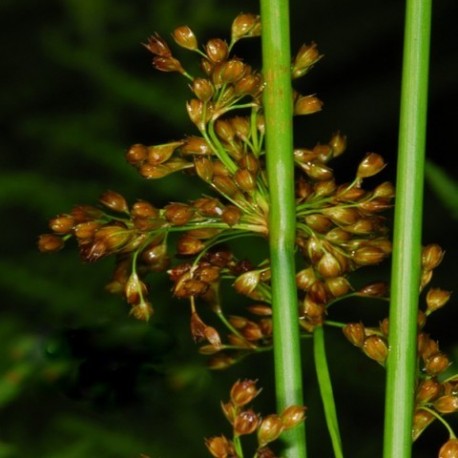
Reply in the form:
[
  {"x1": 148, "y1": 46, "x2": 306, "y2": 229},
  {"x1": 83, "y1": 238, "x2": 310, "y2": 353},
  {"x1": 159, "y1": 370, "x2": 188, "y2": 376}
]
[{"x1": 313, "y1": 326, "x2": 343, "y2": 458}]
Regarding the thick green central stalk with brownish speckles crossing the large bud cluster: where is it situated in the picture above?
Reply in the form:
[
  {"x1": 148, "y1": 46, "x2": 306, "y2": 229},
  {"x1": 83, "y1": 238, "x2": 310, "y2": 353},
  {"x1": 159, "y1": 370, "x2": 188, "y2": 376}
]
[{"x1": 261, "y1": 0, "x2": 306, "y2": 458}]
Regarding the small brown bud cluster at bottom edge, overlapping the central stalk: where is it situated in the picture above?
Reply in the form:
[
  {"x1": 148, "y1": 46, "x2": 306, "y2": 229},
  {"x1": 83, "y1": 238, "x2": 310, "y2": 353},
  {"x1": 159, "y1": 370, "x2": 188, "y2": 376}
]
[{"x1": 205, "y1": 380, "x2": 306, "y2": 458}]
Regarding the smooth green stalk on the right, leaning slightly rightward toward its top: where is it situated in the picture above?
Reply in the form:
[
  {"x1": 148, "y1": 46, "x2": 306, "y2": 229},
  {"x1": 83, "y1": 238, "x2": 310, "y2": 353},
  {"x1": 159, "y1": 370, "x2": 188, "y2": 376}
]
[{"x1": 383, "y1": 0, "x2": 431, "y2": 458}]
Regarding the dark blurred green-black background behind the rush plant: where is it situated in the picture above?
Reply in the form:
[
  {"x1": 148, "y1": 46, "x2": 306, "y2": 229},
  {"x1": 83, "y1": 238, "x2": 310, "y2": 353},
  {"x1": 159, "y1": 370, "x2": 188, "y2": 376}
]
[{"x1": 0, "y1": 0, "x2": 458, "y2": 458}]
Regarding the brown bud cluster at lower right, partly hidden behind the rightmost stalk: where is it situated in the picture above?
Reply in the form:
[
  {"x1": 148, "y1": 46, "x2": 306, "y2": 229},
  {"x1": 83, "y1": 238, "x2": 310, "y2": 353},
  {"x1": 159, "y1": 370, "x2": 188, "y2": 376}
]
[{"x1": 343, "y1": 244, "x2": 458, "y2": 448}]
